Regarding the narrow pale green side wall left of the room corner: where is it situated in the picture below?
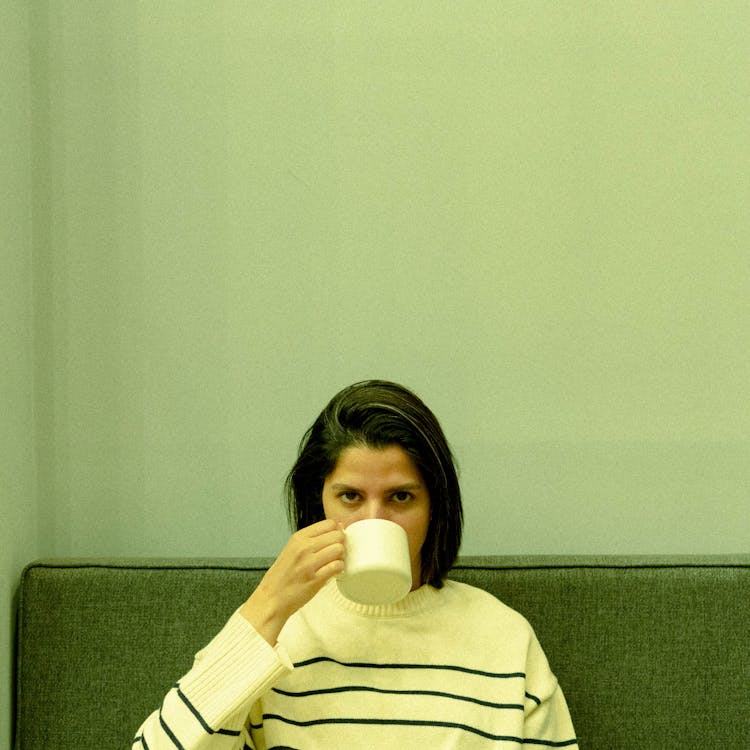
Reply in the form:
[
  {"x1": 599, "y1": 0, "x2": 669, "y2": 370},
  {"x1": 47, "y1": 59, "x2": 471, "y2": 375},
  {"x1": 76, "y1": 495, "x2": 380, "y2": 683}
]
[{"x1": 0, "y1": 0, "x2": 40, "y2": 748}]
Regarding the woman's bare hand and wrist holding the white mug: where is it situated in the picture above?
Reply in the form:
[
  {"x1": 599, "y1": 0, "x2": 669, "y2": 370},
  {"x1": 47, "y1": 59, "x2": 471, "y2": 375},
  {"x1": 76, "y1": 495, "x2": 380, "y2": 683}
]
[{"x1": 240, "y1": 520, "x2": 345, "y2": 646}]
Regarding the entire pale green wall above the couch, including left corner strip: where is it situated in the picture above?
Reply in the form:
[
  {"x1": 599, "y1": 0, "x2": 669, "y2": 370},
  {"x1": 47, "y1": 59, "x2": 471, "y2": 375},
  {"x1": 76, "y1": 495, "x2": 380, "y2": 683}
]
[{"x1": 0, "y1": 0, "x2": 750, "y2": 748}]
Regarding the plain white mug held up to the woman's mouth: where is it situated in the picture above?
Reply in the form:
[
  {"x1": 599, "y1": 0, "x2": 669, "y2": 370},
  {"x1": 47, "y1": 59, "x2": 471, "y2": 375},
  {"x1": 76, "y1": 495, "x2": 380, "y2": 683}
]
[{"x1": 337, "y1": 518, "x2": 411, "y2": 604}]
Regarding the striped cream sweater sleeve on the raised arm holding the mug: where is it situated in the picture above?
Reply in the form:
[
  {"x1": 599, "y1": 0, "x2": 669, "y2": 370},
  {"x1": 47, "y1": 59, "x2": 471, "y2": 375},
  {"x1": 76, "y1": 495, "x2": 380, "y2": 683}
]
[{"x1": 133, "y1": 612, "x2": 293, "y2": 750}]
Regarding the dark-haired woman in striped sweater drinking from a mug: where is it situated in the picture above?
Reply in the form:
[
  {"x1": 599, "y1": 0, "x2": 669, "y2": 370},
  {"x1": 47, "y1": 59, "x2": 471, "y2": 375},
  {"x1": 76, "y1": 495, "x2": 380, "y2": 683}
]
[{"x1": 133, "y1": 381, "x2": 577, "y2": 750}]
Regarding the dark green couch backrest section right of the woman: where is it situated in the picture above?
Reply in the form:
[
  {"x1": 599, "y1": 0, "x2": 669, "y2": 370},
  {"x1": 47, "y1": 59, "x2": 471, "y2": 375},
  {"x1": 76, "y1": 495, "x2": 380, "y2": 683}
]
[{"x1": 454, "y1": 556, "x2": 750, "y2": 750}]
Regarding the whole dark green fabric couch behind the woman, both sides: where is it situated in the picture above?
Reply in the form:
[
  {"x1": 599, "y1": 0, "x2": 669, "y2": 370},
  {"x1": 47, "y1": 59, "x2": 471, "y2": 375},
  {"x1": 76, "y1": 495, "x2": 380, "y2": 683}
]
[{"x1": 16, "y1": 555, "x2": 750, "y2": 750}]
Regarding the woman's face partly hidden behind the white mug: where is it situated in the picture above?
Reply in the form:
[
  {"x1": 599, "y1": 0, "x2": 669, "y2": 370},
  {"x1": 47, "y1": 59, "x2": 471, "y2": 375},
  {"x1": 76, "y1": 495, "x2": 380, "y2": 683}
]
[{"x1": 323, "y1": 445, "x2": 430, "y2": 589}]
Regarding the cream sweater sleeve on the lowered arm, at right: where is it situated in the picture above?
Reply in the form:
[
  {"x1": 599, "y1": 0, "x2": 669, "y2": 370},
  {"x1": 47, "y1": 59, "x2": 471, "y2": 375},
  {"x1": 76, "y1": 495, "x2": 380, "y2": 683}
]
[{"x1": 524, "y1": 637, "x2": 578, "y2": 750}]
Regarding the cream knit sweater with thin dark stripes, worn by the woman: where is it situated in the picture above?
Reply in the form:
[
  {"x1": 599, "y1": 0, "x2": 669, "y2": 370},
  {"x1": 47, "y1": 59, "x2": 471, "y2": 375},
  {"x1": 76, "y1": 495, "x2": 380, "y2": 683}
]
[{"x1": 133, "y1": 581, "x2": 578, "y2": 750}]
